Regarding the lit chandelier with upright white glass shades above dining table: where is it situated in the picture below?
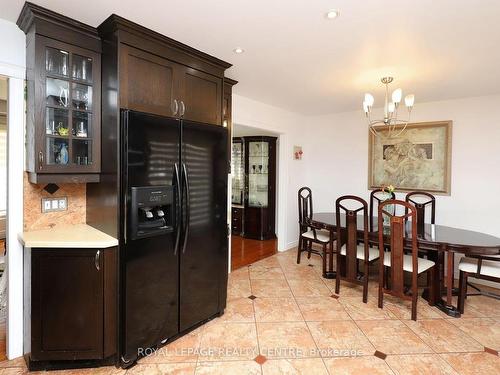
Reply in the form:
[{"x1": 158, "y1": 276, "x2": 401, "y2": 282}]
[{"x1": 363, "y1": 77, "x2": 415, "y2": 138}]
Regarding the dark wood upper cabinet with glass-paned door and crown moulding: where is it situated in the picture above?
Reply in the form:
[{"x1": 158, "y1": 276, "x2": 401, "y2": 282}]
[{"x1": 18, "y1": 3, "x2": 101, "y2": 183}]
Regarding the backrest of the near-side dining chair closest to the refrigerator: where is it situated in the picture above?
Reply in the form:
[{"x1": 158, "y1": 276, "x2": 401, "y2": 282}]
[{"x1": 335, "y1": 195, "x2": 369, "y2": 280}]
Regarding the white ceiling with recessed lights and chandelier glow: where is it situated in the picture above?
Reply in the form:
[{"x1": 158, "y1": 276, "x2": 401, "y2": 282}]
[{"x1": 0, "y1": 0, "x2": 500, "y2": 115}]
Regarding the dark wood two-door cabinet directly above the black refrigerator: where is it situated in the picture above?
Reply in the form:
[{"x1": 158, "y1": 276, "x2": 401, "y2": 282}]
[{"x1": 98, "y1": 15, "x2": 231, "y2": 125}]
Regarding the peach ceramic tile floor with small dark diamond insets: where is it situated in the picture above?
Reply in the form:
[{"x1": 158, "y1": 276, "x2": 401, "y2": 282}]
[{"x1": 0, "y1": 250, "x2": 500, "y2": 375}]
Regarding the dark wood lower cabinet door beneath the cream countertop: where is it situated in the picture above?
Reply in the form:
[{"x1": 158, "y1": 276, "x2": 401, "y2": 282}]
[{"x1": 31, "y1": 249, "x2": 104, "y2": 360}]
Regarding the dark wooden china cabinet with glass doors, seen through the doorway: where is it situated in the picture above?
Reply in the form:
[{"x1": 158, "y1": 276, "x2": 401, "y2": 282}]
[{"x1": 231, "y1": 136, "x2": 276, "y2": 240}]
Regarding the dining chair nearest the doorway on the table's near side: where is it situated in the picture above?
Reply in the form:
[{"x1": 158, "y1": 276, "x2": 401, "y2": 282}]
[{"x1": 335, "y1": 195, "x2": 379, "y2": 303}]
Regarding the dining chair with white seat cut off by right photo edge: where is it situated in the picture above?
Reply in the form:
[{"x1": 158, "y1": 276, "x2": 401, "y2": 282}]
[{"x1": 457, "y1": 255, "x2": 500, "y2": 314}]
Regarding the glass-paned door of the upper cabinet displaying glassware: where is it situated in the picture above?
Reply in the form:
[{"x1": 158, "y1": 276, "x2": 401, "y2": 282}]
[{"x1": 34, "y1": 36, "x2": 101, "y2": 173}]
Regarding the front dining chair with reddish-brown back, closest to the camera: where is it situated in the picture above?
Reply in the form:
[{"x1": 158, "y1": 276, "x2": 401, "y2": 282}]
[{"x1": 378, "y1": 199, "x2": 435, "y2": 320}]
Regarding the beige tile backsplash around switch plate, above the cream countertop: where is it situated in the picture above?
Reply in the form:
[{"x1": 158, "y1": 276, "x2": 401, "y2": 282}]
[{"x1": 24, "y1": 173, "x2": 87, "y2": 231}]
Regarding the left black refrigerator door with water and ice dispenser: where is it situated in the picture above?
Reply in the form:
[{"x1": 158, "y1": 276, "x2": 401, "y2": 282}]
[{"x1": 121, "y1": 111, "x2": 180, "y2": 362}]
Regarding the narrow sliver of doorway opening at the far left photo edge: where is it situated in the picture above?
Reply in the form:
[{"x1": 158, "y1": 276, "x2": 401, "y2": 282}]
[{"x1": 0, "y1": 76, "x2": 8, "y2": 361}]
